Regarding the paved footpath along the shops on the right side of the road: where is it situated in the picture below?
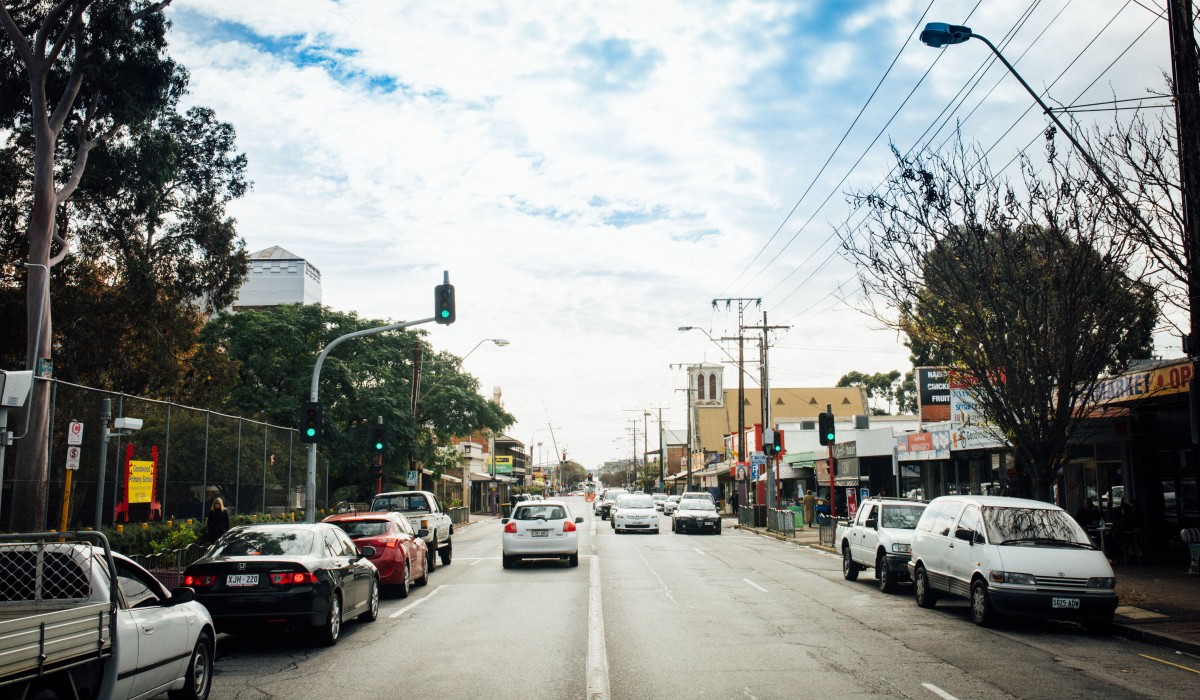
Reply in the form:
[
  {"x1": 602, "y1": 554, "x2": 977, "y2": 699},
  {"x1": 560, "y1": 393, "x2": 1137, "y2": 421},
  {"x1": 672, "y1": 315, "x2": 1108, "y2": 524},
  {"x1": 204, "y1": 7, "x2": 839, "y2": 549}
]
[{"x1": 725, "y1": 514, "x2": 1200, "y2": 657}]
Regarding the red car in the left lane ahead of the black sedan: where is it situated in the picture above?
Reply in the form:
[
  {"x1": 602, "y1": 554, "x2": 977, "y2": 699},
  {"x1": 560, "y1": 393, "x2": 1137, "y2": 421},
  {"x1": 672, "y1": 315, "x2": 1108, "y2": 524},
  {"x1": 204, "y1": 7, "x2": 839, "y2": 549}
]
[{"x1": 325, "y1": 513, "x2": 430, "y2": 598}]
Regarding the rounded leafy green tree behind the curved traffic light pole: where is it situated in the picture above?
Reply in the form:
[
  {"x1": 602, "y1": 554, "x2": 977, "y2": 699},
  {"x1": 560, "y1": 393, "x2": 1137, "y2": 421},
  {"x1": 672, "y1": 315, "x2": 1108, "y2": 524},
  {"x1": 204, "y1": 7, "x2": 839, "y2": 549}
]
[{"x1": 200, "y1": 304, "x2": 514, "y2": 499}]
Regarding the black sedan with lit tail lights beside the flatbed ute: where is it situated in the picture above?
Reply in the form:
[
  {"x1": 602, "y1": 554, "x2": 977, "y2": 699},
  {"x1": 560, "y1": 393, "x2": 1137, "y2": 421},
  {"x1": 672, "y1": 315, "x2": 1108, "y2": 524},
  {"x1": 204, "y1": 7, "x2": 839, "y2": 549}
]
[{"x1": 182, "y1": 522, "x2": 379, "y2": 645}]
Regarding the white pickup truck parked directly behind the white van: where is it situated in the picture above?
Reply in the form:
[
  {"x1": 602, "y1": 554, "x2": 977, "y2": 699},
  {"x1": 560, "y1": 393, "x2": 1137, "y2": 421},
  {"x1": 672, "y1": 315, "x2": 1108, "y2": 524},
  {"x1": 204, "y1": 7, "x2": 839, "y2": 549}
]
[{"x1": 834, "y1": 498, "x2": 925, "y2": 593}]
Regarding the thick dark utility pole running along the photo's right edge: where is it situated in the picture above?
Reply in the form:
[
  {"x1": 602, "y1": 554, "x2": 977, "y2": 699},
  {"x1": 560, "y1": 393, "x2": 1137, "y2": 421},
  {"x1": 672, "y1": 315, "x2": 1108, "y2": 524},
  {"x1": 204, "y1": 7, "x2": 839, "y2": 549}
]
[{"x1": 1166, "y1": 0, "x2": 1200, "y2": 444}]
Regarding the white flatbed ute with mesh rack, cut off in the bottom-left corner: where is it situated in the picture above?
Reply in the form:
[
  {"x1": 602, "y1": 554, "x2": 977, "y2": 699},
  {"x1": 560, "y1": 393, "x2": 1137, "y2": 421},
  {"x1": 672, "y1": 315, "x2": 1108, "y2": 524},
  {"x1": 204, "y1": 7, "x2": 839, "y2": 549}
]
[{"x1": 0, "y1": 532, "x2": 216, "y2": 700}]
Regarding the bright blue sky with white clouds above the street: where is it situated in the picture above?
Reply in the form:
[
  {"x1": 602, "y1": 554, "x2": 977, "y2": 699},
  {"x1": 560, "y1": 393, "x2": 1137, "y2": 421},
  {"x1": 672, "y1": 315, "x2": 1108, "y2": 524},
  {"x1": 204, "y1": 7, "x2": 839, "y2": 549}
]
[{"x1": 168, "y1": 0, "x2": 1181, "y2": 467}]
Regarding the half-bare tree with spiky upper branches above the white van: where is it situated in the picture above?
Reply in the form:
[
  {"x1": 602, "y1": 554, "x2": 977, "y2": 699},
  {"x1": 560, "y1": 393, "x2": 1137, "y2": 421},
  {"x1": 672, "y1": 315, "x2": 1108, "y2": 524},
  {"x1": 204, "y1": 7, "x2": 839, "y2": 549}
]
[{"x1": 842, "y1": 136, "x2": 1158, "y2": 499}]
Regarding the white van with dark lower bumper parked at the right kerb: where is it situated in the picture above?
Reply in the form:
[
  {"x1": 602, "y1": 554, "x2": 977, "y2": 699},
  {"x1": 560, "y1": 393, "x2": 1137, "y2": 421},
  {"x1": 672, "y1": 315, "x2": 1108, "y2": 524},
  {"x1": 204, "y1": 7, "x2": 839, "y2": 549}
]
[{"x1": 908, "y1": 496, "x2": 1117, "y2": 632}]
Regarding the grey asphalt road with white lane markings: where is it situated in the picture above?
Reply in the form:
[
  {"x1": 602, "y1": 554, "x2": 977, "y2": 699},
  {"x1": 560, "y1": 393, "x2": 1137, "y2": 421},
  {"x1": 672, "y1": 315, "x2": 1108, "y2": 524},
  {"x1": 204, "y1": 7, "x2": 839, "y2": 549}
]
[{"x1": 204, "y1": 499, "x2": 1200, "y2": 700}]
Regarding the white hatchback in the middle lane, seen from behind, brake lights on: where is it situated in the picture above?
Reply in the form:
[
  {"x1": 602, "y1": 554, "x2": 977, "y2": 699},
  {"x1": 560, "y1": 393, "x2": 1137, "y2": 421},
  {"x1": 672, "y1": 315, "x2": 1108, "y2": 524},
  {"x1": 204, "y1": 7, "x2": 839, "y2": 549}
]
[{"x1": 500, "y1": 501, "x2": 583, "y2": 569}]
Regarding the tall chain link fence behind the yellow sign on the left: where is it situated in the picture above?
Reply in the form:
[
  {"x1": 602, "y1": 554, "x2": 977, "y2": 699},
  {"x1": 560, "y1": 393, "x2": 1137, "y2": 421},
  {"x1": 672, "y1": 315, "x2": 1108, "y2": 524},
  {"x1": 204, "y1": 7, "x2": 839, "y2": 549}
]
[{"x1": 0, "y1": 379, "x2": 329, "y2": 528}]
